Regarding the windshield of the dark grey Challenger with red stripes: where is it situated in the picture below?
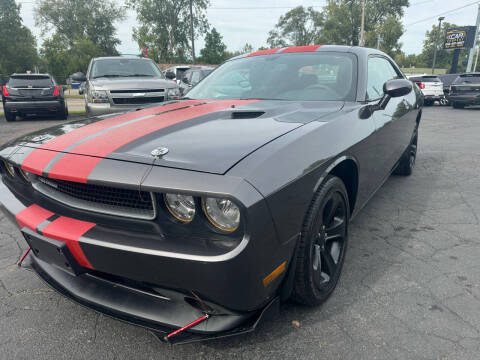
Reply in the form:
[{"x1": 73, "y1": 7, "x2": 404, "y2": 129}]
[{"x1": 188, "y1": 52, "x2": 357, "y2": 101}]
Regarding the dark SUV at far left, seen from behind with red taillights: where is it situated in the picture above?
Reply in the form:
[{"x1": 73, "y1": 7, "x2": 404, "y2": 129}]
[{"x1": 2, "y1": 73, "x2": 68, "y2": 121}]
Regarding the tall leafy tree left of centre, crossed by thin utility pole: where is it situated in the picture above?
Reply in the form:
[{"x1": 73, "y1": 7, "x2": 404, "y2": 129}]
[{"x1": 127, "y1": 0, "x2": 210, "y2": 63}]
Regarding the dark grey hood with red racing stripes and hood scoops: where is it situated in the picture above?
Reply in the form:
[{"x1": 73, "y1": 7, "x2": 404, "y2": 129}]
[{"x1": 9, "y1": 100, "x2": 343, "y2": 174}]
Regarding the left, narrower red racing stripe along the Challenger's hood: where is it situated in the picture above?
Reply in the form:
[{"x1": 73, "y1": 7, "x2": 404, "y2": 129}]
[{"x1": 22, "y1": 100, "x2": 201, "y2": 175}]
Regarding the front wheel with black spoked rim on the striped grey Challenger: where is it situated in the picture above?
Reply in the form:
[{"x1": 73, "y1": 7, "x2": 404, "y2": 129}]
[{"x1": 292, "y1": 176, "x2": 350, "y2": 306}]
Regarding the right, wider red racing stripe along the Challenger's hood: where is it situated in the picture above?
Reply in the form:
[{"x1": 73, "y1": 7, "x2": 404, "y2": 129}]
[{"x1": 49, "y1": 100, "x2": 258, "y2": 183}]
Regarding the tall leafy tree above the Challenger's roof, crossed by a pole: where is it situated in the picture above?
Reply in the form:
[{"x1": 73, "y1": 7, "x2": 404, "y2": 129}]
[{"x1": 320, "y1": 0, "x2": 409, "y2": 56}]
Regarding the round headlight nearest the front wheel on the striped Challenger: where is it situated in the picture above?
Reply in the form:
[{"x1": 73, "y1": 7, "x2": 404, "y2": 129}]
[{"x1": 202, "y1": 198, "x2": 240, "y2": 232}]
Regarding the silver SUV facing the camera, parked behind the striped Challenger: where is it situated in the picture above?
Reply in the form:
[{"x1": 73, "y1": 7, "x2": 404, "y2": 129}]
[{"x1": 72, "y1": 56, "x2": 180, "y2": 116}]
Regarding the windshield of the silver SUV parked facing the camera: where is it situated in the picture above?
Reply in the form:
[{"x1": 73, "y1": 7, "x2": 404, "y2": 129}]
[{"x1": 90, "y1": 58, "x2": 163, "y2": 79}]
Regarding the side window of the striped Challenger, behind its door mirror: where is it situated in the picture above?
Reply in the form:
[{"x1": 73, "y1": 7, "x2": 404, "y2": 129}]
[{"x1": 367, "y1": 57, "x2": 399, "y2": 100}]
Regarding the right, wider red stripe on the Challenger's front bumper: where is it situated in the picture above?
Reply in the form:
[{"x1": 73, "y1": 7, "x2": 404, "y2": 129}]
[{"x1": 42, "y1": 216, "x2": 96, "y2": 269}]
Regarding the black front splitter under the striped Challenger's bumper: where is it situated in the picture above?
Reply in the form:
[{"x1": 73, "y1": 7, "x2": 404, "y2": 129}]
[{"x1": 23, "y1": 255, "x2": 280, "y2": 344}]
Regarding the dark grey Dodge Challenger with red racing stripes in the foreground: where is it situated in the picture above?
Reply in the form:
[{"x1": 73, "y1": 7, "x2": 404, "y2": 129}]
[{"x1": 0, "y1": 45, "x2": 423, "y2": 342}]
